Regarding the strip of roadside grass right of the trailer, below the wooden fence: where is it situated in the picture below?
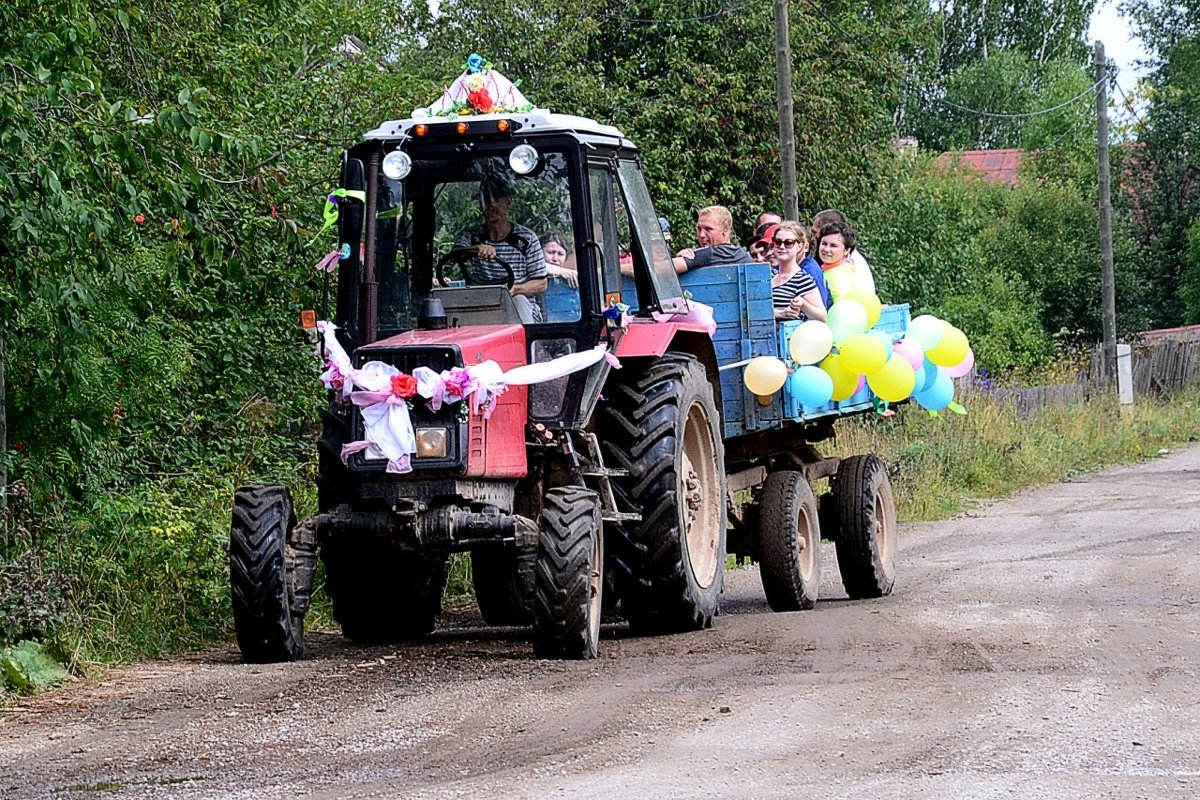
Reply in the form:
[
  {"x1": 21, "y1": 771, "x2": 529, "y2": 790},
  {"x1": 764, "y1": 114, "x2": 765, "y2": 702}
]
[{"x1": 830, "y1": 387, "x2": 1200, "y2": 521}]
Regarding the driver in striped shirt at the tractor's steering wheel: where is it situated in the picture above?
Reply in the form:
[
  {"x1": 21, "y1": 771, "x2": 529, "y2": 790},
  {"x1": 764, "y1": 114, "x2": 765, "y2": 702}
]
[{"x1": 455, "y1": 175, "x2": 547, "y2": 323}]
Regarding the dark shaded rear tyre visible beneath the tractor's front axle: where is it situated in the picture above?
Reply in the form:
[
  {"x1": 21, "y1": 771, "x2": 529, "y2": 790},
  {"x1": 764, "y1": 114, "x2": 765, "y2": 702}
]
[{"x1": 322, "y1": 535, "x2": 448, "y2": 644}]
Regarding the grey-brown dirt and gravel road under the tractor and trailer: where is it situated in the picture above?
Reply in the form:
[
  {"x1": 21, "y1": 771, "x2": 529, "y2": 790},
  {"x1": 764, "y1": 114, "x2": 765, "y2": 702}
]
[{"x1": 0, "y1": 447, "x2": 1200, "y2": 800}]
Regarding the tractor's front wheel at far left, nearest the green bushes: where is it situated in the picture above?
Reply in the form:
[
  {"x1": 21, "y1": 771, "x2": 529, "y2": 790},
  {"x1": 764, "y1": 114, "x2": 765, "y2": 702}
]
[{"x1": 229, "y1": 486, "x2": 307, "y2": 663}]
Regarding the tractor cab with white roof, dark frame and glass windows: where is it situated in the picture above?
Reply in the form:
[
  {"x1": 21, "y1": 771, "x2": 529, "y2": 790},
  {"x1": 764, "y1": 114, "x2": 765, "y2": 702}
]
[{"x1": 335, "y1": 109, "x2": 685, "y2": 362}]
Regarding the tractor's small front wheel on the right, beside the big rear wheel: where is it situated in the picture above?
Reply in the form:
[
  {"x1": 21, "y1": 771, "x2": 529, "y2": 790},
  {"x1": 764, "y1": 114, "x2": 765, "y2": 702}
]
[{"x1": 533, "y1": 487, "x2": 604, "y2": 658}]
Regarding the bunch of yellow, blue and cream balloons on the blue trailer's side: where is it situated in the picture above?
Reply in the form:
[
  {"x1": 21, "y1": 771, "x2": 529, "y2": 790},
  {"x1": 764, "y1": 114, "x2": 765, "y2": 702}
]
[{"x1": 744, "y1": 289, "x2": 974, "y2": 411}]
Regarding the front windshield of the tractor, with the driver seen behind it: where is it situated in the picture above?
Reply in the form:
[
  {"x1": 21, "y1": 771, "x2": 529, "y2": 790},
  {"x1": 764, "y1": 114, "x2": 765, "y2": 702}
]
[{"x1": 374, "y1": 143, "x2": 580, "y2": 336}]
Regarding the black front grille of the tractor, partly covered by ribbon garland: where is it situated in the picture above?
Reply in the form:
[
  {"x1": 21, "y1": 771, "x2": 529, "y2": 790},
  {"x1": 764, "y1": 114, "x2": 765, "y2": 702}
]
[{"x1": 349, "y1": 345, "x2": 467, "y2": 475}]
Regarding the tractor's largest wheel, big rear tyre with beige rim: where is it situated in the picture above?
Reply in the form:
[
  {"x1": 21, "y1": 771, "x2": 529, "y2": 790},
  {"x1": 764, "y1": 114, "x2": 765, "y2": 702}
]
[{"x1": 601, "y1": 353, "x2": 727, "y2": 631}]
